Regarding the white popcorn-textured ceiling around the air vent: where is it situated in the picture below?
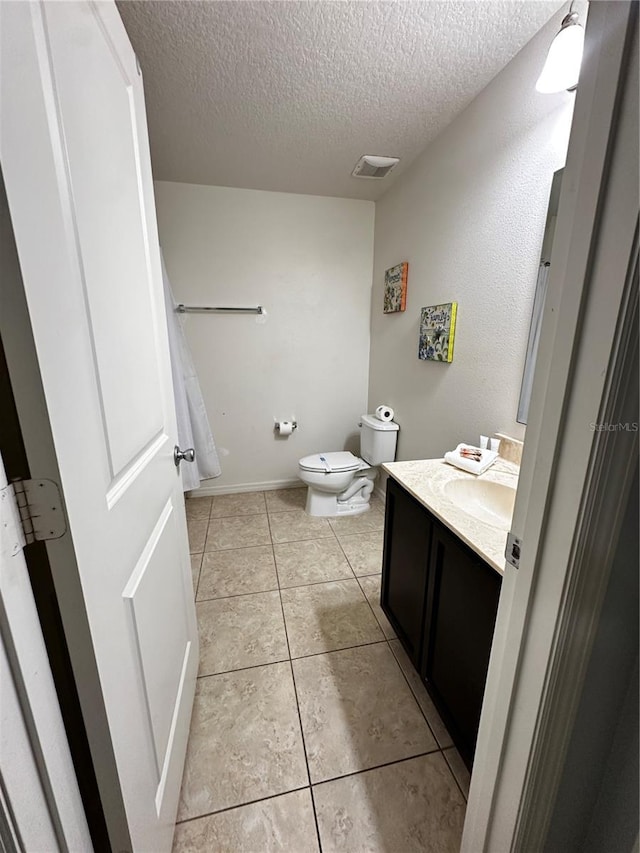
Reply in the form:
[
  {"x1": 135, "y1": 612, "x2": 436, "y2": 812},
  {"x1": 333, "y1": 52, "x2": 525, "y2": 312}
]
[{"x1": 118, "y1": 0, "x2": 562, "y2": 199}]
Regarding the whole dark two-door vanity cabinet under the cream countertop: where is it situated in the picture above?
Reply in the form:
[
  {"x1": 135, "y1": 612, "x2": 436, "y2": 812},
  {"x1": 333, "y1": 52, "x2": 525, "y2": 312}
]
[{"x1": 381, "y1": 478, "x2": 502, "y2": 767}]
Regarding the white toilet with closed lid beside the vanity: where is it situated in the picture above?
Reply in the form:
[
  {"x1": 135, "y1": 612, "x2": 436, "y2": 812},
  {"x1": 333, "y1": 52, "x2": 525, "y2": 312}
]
[{"x1": 298, "y1": 415, "x2": 399, "y2": 517}]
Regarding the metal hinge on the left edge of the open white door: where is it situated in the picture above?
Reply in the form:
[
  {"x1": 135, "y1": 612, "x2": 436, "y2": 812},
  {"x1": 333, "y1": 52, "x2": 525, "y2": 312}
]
[{"x1": 2, "y1": 480, "x2": 67, "y2": 547}]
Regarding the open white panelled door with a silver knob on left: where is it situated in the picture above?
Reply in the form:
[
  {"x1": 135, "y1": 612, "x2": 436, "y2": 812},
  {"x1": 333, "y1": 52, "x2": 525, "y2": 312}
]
[{"x1": 0, "y1": 0, "x2": 198, "y2": 853}]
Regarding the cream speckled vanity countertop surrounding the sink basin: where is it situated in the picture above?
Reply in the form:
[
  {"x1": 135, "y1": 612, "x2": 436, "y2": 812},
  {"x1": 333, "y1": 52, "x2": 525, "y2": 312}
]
[{"x1": 382, "y1": 459, "x2": 520, "y2": 575}]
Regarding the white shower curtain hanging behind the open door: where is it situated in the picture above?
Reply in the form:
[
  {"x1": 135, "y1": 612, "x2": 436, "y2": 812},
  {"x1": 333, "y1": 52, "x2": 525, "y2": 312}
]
[{"x1": 162, "y1": 253, "x2": 222, "y2": 492}]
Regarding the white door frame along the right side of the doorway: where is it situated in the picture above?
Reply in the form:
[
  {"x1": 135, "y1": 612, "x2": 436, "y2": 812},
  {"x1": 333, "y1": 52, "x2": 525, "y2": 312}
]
[{"x1": 462, "y1": 0, "x2": 638, "y2": 853}]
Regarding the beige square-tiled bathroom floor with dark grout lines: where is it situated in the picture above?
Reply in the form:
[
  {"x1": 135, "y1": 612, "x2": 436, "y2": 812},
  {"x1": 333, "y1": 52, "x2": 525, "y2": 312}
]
[{"x1": 174, "y1": 489, "x2": 469, "y2": 853}]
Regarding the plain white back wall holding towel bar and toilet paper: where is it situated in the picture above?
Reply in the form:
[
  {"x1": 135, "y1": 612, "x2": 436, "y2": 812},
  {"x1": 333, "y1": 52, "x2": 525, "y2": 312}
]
[{"x1": 155, "y1": 181, "x2": 374, "y2": 491}]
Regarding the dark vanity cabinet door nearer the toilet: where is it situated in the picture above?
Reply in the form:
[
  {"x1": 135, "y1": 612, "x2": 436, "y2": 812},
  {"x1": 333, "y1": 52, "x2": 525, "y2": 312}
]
[{"x1": 381, "y1": 479, "x2": 432, "y2": 667}]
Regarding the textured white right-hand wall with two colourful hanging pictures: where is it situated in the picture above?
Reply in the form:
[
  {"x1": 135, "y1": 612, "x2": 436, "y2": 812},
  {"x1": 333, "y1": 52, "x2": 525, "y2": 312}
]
[{"x1": 369, "y1": 10, "x2": 574, "y2": 459}]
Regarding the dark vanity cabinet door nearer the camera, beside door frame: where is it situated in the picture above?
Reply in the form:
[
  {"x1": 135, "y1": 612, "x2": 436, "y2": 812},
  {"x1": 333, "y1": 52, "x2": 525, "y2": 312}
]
[{"x1": 421, "y1": 523, "x2": 502, "y2": 765}]
